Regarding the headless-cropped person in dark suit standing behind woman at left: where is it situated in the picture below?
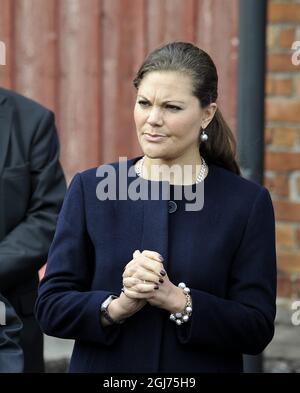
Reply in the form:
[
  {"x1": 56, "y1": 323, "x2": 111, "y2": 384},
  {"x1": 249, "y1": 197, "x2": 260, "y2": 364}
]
[{"x1": 0, "y1": 88, "x2": 66, "y2": 372}]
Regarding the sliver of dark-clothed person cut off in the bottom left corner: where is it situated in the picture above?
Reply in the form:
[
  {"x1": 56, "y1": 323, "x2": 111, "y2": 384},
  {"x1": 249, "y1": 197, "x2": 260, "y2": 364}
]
[{"x1": 0, "y1": 294, "x2": 24, "y2": 373}]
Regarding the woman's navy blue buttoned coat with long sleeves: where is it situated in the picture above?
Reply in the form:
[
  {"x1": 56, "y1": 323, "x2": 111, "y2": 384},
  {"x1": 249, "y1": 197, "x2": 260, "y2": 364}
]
[{"x1": 36, "y1": 158, "x2": 276, "y2": 372}]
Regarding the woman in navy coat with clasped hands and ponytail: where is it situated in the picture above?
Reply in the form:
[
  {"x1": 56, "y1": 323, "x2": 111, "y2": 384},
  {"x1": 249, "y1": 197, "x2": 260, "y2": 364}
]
[{"x1": 37, "y1": 42, "x2": 276, "y2": 372}]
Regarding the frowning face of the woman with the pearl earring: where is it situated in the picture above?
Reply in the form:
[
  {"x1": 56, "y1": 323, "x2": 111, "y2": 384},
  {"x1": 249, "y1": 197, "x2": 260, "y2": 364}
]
[{"x1": 134, "y1": 71, "x2": 213, "y2": 160}]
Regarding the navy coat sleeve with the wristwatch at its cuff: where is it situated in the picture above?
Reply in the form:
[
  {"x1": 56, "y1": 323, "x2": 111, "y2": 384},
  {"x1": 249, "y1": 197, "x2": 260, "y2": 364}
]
[{"x1": 36, "y1": 174, "x2": 120, "y2": 345}]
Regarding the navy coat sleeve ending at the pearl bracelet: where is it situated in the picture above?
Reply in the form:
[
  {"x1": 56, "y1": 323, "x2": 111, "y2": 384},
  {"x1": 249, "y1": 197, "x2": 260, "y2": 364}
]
[{"x1": 177, "y1": 188, "x2": 276, "y2": 355}]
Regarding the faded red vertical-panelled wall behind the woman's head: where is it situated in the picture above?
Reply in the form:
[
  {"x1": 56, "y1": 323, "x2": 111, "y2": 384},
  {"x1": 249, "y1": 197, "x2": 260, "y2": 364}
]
[{"x1": 0, "y1": 0, "x2": 239, "y2": 180}]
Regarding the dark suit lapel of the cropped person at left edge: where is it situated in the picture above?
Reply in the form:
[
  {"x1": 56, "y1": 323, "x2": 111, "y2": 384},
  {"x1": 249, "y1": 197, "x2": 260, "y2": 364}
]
[{"x1": 0, "y1": 95, "x2": 13, "y2": 175}]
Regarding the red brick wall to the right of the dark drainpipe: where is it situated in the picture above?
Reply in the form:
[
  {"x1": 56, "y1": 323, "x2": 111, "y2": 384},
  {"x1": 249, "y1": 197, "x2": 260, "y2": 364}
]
[{"x1": 265, "y1": 0, "x2": 300, "y2": 298}]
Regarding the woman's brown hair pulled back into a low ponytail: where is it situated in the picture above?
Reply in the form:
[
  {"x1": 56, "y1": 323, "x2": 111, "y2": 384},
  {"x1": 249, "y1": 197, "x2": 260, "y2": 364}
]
[{"x1": 133, "y1": 42, "x2": 240, "y2": 175}]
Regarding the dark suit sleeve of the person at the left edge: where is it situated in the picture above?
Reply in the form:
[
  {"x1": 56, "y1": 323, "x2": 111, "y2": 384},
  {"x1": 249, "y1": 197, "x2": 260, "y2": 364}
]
[{"x1": 0, "y1": 111, "x2": 66, "y2": 292}]
